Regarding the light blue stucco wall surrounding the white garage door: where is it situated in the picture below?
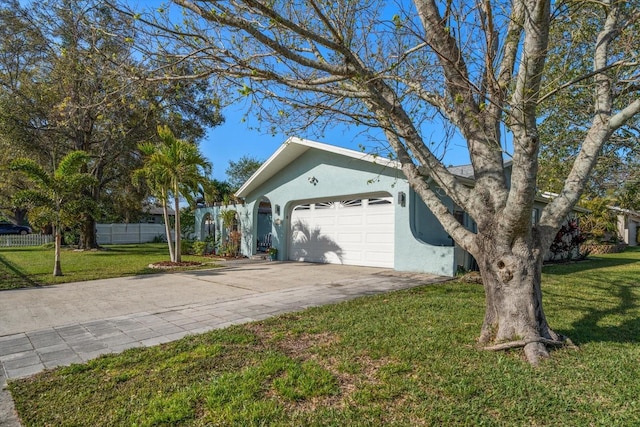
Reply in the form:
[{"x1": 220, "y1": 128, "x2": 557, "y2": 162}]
[{"x1": 196, "y1": 148, "x2": 456, "y2": 276}]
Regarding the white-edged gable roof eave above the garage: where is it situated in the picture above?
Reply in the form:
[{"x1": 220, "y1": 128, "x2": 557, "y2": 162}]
[{"x1": 236, "y1": 137, "x2": 400, "y2": 197}]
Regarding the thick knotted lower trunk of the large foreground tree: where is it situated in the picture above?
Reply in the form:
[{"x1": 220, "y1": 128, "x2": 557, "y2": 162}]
[{"x1": 476, "y1": 238, "x2": 564, "y2": 365}]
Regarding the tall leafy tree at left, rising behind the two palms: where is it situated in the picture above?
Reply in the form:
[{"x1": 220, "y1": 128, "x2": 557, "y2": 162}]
[{"x1": 0, "y1": 0, "x2": 222, "y2": 248}]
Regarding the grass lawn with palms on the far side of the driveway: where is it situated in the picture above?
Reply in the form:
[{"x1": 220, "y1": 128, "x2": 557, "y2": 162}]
[{"x1": 0, "y1": 243, "x2": 218, "y2": 290}]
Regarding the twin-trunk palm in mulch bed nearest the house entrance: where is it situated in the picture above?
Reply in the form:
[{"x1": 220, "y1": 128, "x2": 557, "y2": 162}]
[{"x1": 138, "y1": 126, "x2": 211, "y2": 262}]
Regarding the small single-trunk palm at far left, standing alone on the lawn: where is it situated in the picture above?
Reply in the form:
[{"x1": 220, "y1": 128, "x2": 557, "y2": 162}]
[{"x1": 10, "y1": 151, "x2": 96, "y2": 276}]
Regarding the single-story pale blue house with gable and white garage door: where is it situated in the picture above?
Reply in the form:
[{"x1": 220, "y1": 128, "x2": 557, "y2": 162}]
[{"x1": 195, "y1": 137, "x2": 568, "y2": 276}]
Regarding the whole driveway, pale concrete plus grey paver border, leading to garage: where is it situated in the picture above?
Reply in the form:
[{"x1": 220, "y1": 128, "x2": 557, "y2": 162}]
[{"x1": 0, "y1": 262, "x2": 448, "y2": 427}]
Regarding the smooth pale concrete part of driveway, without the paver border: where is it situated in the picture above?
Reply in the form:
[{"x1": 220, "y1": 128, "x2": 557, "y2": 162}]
[{"x1": 0, "y1": 262, "x2": 442, "y2": 337}]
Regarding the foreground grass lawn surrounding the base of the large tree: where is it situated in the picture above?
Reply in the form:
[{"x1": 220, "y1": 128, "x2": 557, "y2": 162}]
[{"x1": 9, "y1": 250, "x2": 640, "y2": 426}]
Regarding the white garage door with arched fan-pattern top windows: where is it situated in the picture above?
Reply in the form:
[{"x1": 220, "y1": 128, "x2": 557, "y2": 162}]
[{"x1": 289, "y1": 197, "x2": 394, "y2": 268}]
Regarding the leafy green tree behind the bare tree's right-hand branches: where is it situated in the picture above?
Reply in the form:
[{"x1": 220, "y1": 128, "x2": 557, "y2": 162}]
[{"x1": 538, "y1": 1, "x2": 640, "y2": 204}]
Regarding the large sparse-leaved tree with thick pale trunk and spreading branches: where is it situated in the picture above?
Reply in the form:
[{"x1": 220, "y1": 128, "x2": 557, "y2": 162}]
[{"x1": 125, "y1": 0, "x2": 640, "y2": 363}]
